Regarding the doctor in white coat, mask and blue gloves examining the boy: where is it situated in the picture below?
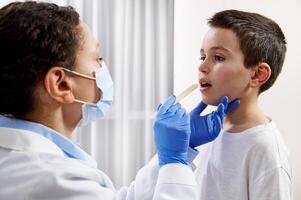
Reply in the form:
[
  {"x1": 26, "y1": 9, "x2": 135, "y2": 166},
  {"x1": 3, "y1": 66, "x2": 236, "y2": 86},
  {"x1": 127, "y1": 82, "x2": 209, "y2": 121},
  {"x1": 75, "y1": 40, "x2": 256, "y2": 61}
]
[{"x1": 0, "y1": 2, "x2": 235, "y2": 200}]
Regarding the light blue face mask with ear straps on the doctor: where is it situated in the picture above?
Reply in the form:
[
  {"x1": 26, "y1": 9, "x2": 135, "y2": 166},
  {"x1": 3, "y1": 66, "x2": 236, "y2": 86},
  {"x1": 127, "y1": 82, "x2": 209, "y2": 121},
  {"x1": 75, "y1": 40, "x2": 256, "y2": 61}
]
[{"x1": 64, "y1": 62, "x2": 114, "y2": 126}]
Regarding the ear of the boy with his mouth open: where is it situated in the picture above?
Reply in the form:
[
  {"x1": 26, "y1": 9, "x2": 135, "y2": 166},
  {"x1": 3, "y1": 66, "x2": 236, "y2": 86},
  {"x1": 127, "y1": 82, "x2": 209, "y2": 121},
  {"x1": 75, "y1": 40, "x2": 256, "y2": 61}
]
[{"x1": 250, "y1": 63, "x2": 272, "y2": 87}]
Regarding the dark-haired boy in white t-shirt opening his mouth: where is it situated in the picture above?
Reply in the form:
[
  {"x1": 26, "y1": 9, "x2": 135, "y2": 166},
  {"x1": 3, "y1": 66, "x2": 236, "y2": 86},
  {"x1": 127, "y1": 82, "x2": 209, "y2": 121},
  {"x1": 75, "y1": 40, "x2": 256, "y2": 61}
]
[{"x1": 196, "y1": 10, "x2": 292, "y2": 200}]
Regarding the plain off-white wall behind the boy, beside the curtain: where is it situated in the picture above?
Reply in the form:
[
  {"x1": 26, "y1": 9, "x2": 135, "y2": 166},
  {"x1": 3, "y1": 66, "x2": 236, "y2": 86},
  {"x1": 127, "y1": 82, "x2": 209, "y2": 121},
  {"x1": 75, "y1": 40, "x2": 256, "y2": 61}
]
[{"x1": 174, "y1": 0, "x2": 301, "y2": 199}]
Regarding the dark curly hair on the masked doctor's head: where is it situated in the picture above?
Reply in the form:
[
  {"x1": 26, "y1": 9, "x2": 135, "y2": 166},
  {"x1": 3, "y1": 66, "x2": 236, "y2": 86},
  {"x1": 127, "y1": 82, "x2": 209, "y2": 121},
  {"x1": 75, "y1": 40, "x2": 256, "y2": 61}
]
[{"x1": 0, "y1": 1, "x2": 81, "y2": 117}]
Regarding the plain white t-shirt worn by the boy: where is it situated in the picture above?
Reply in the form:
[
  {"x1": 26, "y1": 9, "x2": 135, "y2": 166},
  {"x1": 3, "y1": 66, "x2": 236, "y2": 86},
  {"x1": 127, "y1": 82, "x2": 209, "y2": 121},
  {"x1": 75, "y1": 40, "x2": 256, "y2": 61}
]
[{"x1": 195, "y1": 122, "x2": 293, "y2": 200}]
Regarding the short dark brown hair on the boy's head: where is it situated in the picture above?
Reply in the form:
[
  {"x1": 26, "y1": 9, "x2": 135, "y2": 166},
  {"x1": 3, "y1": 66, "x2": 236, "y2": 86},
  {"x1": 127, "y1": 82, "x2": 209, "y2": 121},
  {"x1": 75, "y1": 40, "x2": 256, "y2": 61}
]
[{"x1": 208, "y1": 10, "x2": 286, "y2": 93}]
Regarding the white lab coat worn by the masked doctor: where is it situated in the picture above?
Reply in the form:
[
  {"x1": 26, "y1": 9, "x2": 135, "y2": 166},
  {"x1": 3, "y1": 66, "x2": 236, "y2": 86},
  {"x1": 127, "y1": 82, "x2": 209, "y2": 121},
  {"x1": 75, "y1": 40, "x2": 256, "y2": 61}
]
[{"x1": 0, "y1": 127, "x2": 197, "y2": 200}]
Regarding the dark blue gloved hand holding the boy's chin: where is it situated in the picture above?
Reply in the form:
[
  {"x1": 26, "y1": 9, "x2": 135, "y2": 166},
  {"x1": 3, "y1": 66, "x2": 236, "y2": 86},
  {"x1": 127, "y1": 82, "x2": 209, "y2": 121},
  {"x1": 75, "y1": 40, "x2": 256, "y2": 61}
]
[{"x1": 189, "y1": 96, "x2": 240, "y2": 148}]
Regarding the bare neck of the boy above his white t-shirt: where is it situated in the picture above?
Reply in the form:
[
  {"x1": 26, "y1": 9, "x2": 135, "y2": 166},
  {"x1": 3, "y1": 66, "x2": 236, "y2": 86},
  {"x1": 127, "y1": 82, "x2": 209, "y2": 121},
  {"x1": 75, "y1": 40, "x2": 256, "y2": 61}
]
[{"x1": 223, "y1": 97, "x2": 270, "y2": 133}]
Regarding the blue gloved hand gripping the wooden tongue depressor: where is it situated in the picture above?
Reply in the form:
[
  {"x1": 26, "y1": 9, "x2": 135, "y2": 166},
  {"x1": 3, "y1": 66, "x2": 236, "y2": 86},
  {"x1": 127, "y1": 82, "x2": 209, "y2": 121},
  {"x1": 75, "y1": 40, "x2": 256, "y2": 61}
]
[{"x1": 153, "y1": 96, "x2": 190, "y2": 167}]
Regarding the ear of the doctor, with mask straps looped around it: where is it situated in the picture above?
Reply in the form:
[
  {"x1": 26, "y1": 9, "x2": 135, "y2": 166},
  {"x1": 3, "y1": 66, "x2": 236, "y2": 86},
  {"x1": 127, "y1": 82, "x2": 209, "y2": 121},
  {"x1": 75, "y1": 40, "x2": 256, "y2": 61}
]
[{"x1": 44, "y1": 67, "x2": 74, "y2": 103}]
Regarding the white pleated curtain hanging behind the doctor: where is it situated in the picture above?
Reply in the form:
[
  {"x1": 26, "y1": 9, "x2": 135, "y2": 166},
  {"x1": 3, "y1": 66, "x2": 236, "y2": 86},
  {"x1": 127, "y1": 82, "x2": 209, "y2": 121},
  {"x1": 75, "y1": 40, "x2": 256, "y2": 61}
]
[{"x1": 0, "y1": 0, "x2": 174, "y2": 187}]
